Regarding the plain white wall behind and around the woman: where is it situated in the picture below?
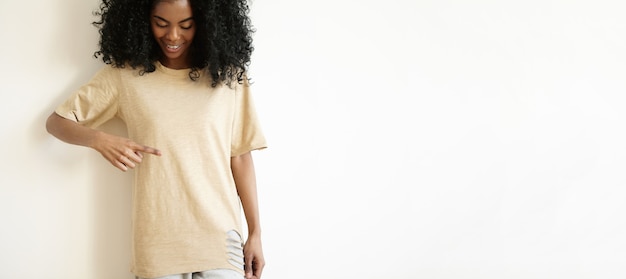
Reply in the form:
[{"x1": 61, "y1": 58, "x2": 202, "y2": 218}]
[{"x1": 0, "y1": 0, "x2": 626, "y2": 279}]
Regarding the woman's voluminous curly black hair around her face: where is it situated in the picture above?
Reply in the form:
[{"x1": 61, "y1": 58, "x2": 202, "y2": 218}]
[{"x1": 93, "y1": 0, "x2": 254, "y2": 87}]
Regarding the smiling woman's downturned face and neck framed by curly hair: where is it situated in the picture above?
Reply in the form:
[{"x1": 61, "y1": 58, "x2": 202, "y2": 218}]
[{"x1": 150, "y1": 0, "x2": 196, "y2": 69}]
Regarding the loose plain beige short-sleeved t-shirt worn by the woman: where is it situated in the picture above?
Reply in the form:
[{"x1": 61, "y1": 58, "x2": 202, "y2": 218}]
[{"x1": 56, "y1": 62, "x2": 266, "y2": 278}]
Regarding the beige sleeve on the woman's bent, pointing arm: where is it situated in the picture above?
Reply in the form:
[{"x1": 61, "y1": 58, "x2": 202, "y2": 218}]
[{"x1": 55, "y1": 65, "x2": 120, "y2": 128}]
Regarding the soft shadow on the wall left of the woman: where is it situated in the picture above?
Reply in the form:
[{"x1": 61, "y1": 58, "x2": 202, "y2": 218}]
[{"x1": 34, "y1": 0, "x2": 134, "y2": 279}]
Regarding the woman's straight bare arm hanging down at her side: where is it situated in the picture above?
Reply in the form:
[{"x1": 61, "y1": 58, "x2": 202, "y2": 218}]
[{"x1": 230, "y1": 152, "x2": 265, "y2": 278}]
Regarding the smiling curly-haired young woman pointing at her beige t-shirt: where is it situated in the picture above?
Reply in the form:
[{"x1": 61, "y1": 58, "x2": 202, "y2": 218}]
[{"x1": 46, "y1": 0, "x2": 266, "y2": 279}]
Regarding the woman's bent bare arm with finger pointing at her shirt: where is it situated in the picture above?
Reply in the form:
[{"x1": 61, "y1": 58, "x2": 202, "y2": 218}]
[{"x1": 46, "y1": 113, "x2": 161, "y2": 171}]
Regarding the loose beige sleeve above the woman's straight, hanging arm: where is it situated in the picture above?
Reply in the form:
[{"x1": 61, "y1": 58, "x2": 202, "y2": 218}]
[{"x1": 231, "y1": 80, "x2": 267, "y2": 157}]
